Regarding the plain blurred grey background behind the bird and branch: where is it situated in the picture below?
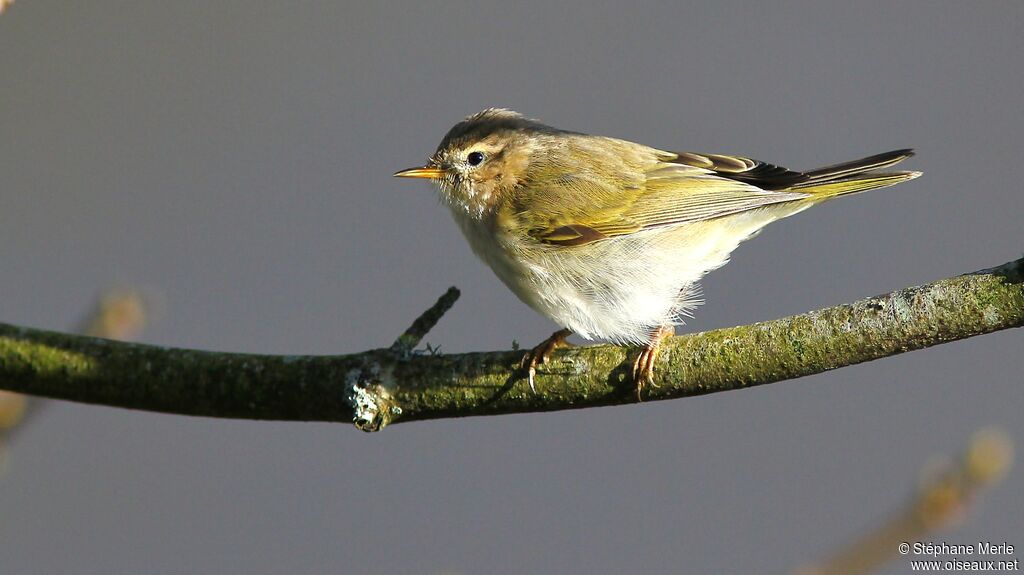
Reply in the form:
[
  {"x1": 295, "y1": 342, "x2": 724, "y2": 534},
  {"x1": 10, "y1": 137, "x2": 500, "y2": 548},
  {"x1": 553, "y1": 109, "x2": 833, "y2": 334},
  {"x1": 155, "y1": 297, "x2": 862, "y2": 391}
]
[{"x1": 0, "y1": 0, "x2": 1024, "y2": 574}]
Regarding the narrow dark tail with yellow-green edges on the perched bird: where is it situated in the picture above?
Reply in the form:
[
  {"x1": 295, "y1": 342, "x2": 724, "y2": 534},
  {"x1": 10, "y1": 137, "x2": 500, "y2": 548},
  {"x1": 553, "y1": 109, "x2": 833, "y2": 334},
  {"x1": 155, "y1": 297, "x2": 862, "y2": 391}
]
[{"x1": 786, "y1": 149, "x2": 921, "y2": 200}]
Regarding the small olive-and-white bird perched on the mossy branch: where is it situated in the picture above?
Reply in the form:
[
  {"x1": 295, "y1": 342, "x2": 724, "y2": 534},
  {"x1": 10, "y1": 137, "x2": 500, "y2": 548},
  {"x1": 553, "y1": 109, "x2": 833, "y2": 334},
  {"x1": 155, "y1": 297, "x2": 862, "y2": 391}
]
[{"x1": 394, "y1": 107, "x2": 921, "y2": 400}]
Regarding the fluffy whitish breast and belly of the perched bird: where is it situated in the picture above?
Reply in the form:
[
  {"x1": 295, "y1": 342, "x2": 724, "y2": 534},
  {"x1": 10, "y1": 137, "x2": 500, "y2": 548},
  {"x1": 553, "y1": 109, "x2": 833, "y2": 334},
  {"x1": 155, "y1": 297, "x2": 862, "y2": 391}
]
[{"x1": 453, "y1": 201, "x2": 804, "y2": 345}]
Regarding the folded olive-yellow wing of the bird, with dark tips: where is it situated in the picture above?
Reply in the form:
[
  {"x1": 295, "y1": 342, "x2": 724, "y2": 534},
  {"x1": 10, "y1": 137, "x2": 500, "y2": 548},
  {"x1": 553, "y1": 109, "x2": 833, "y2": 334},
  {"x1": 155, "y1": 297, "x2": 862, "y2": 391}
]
[{"x1": 526, "y1": 152, "x2": 808, "y2": 247}]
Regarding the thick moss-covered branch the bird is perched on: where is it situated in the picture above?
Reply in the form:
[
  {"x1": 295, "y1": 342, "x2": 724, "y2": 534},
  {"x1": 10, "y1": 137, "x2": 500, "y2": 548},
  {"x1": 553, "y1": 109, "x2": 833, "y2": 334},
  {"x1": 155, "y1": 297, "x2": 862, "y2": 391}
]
[{"x1": 0, "y1": 258, "x2": 1024, "y2": 431}]
